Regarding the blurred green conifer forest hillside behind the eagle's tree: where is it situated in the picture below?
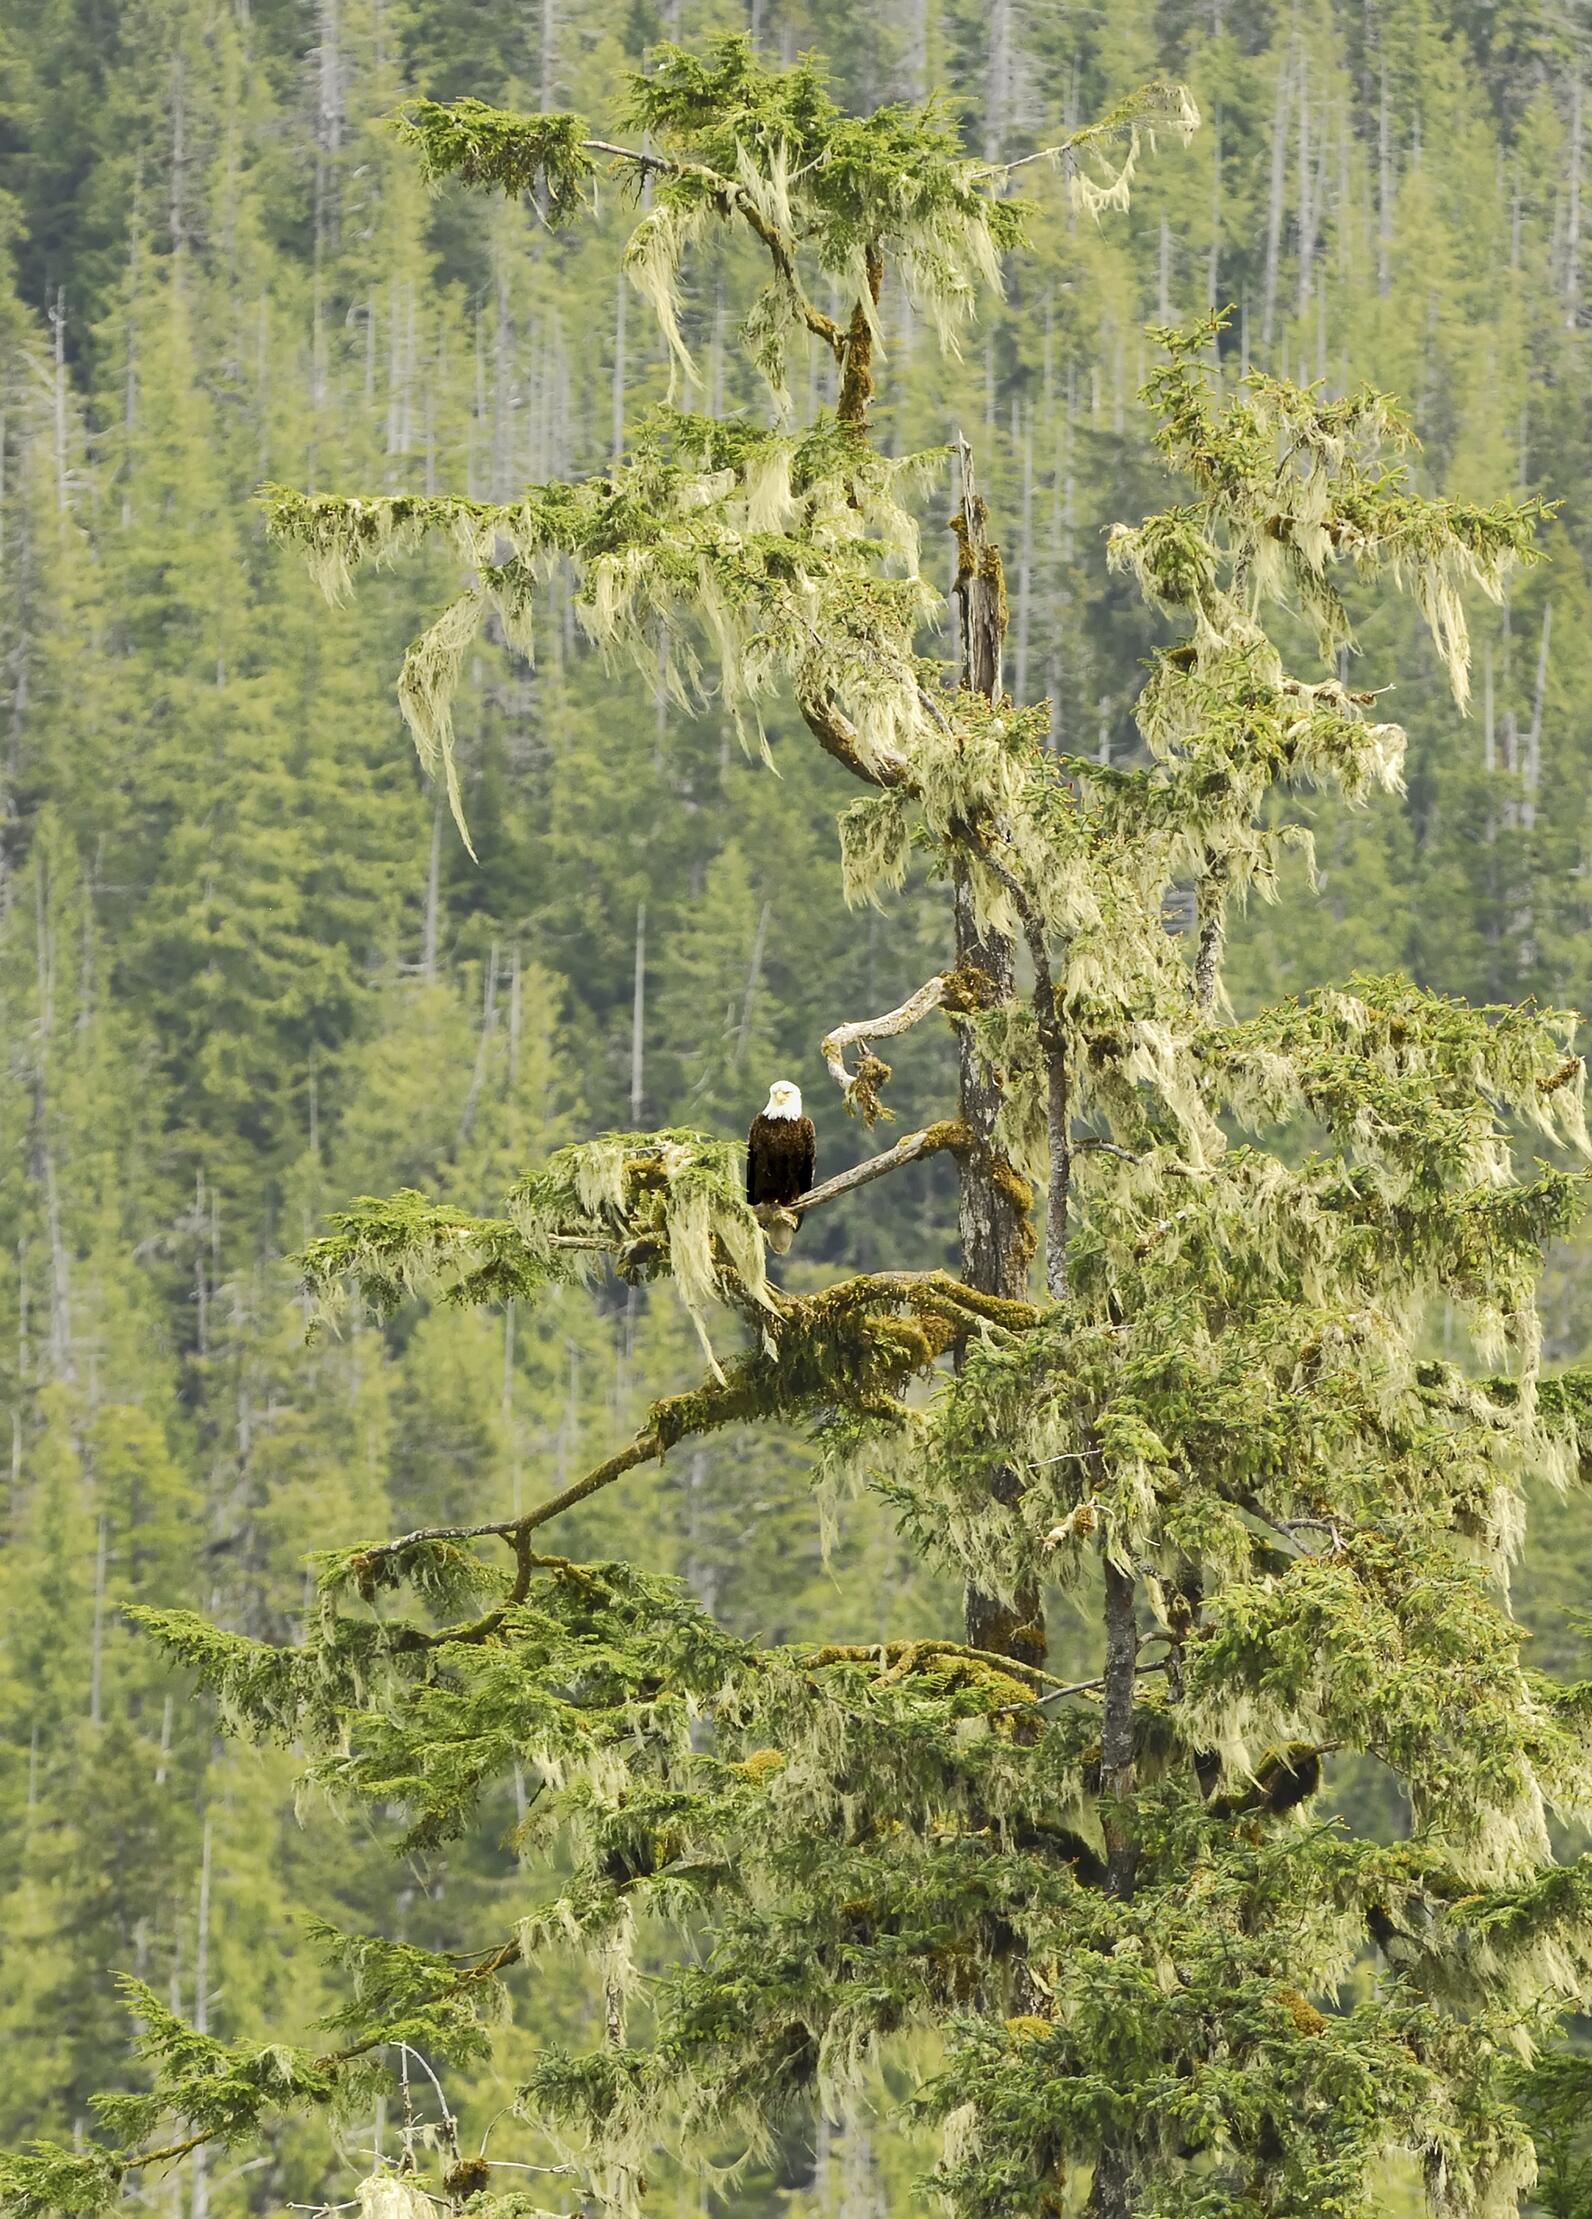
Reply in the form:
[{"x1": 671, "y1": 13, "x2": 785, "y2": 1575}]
[{"x1": 0, "y1": 0, "x2": 1592, "y2": 2219}]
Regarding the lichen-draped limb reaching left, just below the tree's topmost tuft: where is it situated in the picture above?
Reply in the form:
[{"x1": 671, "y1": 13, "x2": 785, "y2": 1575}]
[{"x1": 262, "y1": 411, "x2": 937, "y2": 838}]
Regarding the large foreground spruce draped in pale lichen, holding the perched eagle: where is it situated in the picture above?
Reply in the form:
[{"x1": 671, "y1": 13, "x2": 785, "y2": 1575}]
[{"x1": 0, "y1": 40, "x2": 1592, "y2": 2219}]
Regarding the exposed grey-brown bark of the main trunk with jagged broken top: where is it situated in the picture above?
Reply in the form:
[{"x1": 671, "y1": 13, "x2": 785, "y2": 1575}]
[{"x1": 953, "y1": 444, "x2": 1046, "y2": 1664}]
